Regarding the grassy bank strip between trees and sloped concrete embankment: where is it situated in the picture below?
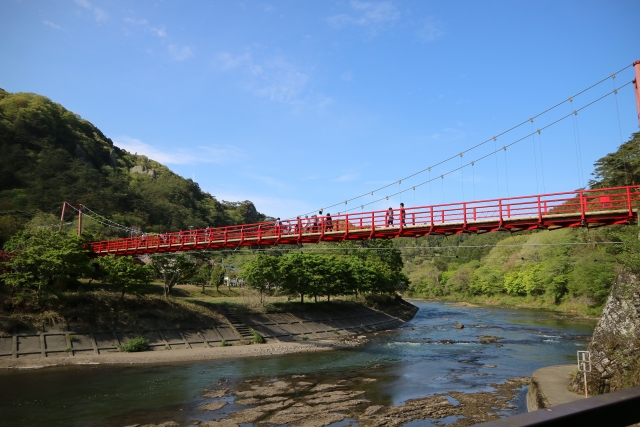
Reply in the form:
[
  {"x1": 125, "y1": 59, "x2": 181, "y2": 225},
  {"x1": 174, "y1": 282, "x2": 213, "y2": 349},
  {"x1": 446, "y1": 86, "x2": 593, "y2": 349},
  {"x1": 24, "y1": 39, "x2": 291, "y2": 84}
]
[{"x1": 0, "y1": 283, "x2": 415, "y2": 335}]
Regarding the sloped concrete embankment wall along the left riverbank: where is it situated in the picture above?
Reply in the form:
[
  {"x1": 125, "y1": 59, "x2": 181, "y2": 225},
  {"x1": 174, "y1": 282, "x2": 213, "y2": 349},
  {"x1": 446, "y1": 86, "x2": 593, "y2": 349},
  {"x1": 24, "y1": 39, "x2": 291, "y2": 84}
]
[{"x1": 0, "y1": 306, "x2": 417, "y2": 360}]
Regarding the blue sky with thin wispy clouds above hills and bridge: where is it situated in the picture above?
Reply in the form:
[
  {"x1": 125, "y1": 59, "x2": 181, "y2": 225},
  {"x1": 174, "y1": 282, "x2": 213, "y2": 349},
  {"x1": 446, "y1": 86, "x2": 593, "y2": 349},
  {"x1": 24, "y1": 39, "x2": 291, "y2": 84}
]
[{"x1": 0, "y1": 0, "x2": 640, "y2": 218}]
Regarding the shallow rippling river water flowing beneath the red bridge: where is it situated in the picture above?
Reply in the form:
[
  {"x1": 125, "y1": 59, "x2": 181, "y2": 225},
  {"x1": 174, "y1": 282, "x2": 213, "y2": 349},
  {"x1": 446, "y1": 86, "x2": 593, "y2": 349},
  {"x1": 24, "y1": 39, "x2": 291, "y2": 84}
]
[{"x1": 0, "y1": 301, "x2": 595, "y2": 427}]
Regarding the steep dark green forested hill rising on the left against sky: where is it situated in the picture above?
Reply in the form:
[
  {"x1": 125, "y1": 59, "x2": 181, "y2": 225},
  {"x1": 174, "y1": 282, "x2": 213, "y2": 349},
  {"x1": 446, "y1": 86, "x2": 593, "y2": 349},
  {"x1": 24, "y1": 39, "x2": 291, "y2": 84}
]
[{"x1": 0, "y1": 89, "x2": 265, "y2": 245}]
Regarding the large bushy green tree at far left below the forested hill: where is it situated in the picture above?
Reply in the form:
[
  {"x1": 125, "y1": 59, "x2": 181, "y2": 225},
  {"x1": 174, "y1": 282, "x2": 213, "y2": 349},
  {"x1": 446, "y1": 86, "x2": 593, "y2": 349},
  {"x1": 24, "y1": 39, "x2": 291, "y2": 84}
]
[{"x1": 0, "y1": 229, "x2": 89, "y2": 302}]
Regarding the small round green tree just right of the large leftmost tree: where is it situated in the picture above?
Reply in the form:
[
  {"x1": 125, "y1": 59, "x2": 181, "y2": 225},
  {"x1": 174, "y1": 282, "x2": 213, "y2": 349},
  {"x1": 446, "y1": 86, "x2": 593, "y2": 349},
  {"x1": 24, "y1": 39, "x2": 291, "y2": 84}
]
[{"x1": 98, "y1": 255, "x2": 152, "y2": 302}]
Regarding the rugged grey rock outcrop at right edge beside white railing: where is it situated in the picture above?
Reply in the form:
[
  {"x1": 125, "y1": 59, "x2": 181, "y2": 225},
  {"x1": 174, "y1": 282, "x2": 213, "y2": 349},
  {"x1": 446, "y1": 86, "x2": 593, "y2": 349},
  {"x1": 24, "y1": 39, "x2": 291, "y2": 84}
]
[{"x1": 572, "y1": 270, "x2": 640, "y2": 394}]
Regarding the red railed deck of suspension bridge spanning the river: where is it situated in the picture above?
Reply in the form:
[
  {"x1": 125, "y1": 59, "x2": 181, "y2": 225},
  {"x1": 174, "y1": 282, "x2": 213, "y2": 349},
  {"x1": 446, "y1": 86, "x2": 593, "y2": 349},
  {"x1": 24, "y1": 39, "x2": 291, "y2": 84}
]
[{"x1": 87, "y1": 185, "x2": 640, "y2": 256}]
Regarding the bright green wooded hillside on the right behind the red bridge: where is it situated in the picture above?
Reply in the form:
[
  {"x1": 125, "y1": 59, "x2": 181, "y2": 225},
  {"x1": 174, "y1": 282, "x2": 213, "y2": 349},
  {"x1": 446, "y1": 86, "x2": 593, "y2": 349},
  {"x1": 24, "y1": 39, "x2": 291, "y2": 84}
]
[{"x1": 402, "y1": 133, "x2": 640, "y2": 314}]
